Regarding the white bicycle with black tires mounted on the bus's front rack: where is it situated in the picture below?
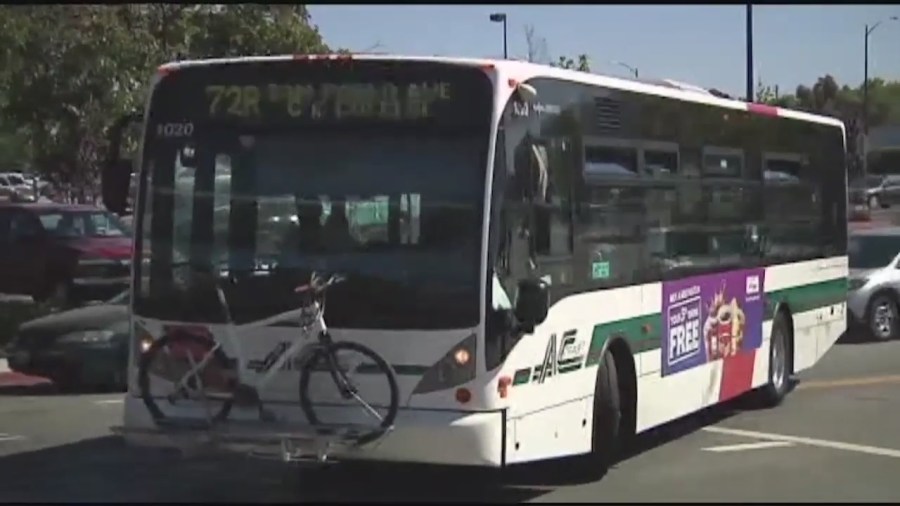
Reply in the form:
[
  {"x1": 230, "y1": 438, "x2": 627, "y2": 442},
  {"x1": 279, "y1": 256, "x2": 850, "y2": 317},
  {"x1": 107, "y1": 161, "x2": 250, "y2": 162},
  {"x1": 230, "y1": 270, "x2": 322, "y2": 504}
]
[{"x1": 138, "y1": 272, "x2": 400, "y2": 445}]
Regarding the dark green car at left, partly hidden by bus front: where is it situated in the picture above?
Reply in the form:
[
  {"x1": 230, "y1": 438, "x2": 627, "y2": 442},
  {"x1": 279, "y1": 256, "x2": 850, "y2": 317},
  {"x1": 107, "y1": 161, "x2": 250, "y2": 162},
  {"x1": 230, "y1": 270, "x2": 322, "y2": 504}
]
[{"x1": 6, "y1": 290, "x2": 130, "y2": 391}]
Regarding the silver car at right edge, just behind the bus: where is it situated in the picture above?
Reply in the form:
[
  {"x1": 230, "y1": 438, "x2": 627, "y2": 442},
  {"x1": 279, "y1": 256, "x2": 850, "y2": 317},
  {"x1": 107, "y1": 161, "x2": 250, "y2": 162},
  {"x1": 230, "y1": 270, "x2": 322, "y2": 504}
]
[{"x1": 847, "y1": 227, "x2": 900, "y2": 341}]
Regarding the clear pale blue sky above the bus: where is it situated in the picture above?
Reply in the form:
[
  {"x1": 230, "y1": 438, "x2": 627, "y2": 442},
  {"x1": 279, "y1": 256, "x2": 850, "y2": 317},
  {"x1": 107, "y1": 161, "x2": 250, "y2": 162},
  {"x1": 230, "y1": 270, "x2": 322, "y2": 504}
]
[{"x1": 309, "y1": 5, "x2": 900, "y2": 96}]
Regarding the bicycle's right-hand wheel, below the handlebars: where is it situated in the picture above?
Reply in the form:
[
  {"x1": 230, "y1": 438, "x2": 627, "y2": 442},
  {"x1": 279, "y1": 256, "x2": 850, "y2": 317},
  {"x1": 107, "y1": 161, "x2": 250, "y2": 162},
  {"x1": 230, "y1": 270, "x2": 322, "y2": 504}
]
[{"x1": 300, "y1": 341, "x2": 400, "y2": 445}]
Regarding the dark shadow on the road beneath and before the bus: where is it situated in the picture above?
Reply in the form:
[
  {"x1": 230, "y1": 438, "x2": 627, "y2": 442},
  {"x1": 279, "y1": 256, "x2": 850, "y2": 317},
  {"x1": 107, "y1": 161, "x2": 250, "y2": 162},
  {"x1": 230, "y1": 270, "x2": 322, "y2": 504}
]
[{"x1": 0, "y1": 390, "x2": 784, "y2": 503}]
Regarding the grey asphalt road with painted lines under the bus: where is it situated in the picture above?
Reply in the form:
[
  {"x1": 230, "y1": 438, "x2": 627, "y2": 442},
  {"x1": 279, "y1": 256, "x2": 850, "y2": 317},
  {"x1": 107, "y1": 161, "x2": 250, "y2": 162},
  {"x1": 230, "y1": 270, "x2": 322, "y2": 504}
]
[{"x1": 0, "y1": 332, "x2": 900, "y2": 502}]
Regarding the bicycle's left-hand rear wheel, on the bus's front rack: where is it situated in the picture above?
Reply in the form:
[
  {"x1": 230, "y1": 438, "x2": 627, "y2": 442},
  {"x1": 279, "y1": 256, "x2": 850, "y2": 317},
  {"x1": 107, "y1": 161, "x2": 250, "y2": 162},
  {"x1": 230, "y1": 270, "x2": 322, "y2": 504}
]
[{"x1": 138, "y1": 334, "x2": 234, "y2": 423}]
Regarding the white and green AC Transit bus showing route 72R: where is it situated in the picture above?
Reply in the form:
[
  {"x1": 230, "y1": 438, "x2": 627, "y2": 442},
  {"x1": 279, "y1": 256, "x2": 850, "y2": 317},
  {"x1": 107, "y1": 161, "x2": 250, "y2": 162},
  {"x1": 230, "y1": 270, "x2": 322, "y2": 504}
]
[{"x1": 104, "y1": 55, "x2": 848, "y2": 467}]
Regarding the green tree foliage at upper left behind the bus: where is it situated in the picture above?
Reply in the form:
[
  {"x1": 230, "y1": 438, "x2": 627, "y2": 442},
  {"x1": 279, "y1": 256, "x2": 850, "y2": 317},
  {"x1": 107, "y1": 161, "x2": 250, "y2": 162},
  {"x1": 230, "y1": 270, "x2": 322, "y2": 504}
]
[{"x1": 0, "y1": 4, "x2": 328, "y2": 179}]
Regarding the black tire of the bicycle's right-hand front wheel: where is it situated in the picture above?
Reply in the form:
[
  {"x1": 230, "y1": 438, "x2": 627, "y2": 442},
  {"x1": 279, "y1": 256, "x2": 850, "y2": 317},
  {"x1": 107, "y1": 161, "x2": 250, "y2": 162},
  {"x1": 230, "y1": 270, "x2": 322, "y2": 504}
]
[{"x1": 300, "y1": 341, "x2": 400, "y2": 445}]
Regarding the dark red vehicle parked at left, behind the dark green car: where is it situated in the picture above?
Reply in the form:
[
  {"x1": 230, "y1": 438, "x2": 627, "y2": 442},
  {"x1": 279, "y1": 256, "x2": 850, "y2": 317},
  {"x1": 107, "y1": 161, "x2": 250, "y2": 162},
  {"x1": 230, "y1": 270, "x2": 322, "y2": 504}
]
[{"x1": 0, "y1": 203, "x2": 132, "y2": 307}]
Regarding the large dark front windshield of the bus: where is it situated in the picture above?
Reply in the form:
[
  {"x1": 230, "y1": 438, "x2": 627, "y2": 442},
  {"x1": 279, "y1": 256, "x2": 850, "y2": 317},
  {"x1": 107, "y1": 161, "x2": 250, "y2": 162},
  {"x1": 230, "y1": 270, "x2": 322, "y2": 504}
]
[{"x1": 134, "y1": 62, "x2": 491, "y2": 329}]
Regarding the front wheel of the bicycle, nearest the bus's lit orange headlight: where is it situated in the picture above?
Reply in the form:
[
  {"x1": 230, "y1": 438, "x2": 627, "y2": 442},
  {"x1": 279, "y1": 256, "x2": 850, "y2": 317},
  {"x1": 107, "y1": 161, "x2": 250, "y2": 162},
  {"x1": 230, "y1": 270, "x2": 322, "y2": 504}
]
[{"x1": 300, "y1": 341, "x2": 400, "y2": 445}]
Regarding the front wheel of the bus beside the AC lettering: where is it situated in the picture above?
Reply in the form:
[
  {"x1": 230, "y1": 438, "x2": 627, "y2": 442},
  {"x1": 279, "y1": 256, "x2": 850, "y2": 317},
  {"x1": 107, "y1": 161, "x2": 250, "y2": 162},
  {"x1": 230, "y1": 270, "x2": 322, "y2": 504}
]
[{"x1": 591, "y1": 351, "x2": 622, "y2": 472}]
